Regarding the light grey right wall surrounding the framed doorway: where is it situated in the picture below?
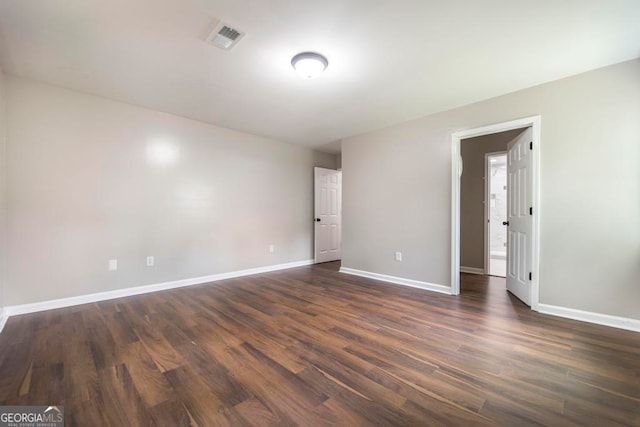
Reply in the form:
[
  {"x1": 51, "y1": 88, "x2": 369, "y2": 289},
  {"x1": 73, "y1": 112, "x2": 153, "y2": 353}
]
[{"x1": 342, "y1": 60, "x2": 640, "y2": 319}]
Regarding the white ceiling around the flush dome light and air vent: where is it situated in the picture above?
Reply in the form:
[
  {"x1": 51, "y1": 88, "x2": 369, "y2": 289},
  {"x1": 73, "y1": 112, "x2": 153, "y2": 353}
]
[{"x1": 0, "y1": 0, "x2": 640, "y2": 152}]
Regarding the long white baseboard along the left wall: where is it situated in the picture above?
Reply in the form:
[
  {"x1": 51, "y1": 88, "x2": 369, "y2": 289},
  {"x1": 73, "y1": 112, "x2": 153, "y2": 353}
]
[{"x1": 5, "y1": 259, "x2": 313, "y2": 317}]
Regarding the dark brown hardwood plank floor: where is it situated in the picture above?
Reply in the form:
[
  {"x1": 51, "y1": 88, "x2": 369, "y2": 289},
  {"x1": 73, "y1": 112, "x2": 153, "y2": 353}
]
[{"x1": 0, "y1": 263, "x2": 640, "y2": 426}]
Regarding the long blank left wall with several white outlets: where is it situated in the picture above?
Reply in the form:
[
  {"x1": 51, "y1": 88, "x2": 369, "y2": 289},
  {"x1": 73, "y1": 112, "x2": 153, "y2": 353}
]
[{"x1": 6, "y1": 76, "x2": 335, "y2": 305}]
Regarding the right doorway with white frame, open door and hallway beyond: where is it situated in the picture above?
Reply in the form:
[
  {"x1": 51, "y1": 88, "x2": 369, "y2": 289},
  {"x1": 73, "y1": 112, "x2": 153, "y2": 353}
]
[{"x1": 451, "y1": 116, "x2": 540, "y2": 310}]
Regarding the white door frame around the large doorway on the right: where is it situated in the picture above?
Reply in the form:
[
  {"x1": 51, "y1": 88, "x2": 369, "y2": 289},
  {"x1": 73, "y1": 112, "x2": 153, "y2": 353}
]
[{"x1": 451, "y1": 116, "x2": 542, "y2": 311}]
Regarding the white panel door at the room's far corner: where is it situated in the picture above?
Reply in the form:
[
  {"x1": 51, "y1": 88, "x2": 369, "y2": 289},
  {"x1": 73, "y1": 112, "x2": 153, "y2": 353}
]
[{"x1": 314, "y1": 168, "x2": 342, "y2": 263}]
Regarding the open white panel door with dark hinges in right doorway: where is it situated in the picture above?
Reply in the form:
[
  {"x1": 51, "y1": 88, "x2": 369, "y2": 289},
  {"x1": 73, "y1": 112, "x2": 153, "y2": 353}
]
[{"x1": 504, "y1": 128, "x2": 533, "y2": 306}]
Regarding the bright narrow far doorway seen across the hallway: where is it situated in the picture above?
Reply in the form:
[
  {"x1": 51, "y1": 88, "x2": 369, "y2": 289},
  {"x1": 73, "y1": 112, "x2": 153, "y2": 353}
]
[{"x1": 484, "y1": 151, "x2": 507, "y2": 277}]
